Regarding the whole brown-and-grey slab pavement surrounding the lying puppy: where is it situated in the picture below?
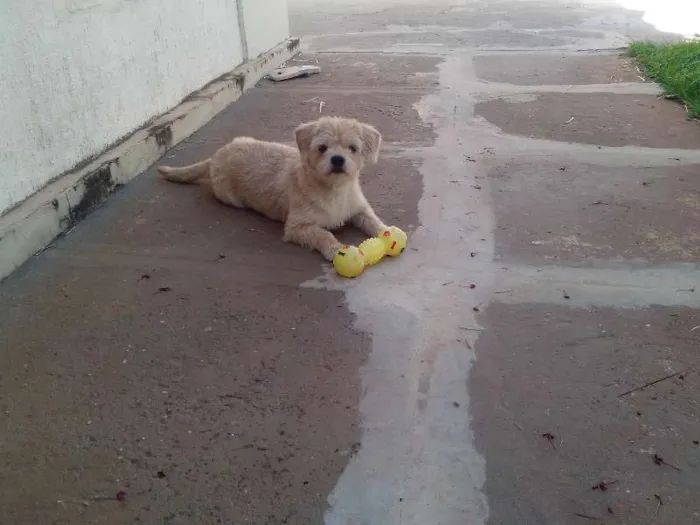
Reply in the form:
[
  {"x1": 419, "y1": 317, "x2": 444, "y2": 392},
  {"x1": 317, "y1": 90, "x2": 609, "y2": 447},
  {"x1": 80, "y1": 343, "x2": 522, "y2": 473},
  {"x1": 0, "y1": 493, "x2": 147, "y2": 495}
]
[{"x1": 0, "y1": 0, "x2": 700, "y2": 525}]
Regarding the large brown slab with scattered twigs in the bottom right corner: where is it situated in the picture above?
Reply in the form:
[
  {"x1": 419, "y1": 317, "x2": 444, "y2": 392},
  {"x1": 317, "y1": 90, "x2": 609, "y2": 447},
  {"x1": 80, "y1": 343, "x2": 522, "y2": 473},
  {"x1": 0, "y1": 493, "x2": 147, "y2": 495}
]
[{"x1": 469, "y1": 304, "x2": 700, "y2": 525}]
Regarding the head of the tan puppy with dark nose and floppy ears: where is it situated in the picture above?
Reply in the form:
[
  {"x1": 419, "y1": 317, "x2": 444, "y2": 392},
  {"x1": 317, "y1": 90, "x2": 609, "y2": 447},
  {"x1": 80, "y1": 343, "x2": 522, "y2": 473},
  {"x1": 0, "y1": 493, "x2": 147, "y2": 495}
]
[{"x1": 295, "y1": 117, "x2": 382, "y2": 184}]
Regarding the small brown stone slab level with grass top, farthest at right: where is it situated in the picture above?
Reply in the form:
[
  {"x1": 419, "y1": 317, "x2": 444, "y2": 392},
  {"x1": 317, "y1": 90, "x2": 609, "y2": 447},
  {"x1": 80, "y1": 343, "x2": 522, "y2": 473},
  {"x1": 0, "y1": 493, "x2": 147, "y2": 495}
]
[{"x1": 474, "y1": 54, "x2": 640, "y2": 86}]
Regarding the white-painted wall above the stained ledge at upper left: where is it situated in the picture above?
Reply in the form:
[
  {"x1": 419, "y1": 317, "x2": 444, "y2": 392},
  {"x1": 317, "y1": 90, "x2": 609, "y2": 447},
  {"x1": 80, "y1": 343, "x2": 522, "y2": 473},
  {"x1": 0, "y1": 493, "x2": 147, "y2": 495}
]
[{"x1": 0, "y1": 0, "x2": 288, "y2": 213}]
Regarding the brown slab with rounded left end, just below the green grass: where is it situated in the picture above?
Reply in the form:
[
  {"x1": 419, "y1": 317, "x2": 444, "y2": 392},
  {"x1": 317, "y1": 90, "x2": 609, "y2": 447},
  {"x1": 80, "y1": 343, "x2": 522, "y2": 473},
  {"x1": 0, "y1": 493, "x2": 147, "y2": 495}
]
[{"x1": 476, "y1": 93, "x2": 700, "y2": 149}]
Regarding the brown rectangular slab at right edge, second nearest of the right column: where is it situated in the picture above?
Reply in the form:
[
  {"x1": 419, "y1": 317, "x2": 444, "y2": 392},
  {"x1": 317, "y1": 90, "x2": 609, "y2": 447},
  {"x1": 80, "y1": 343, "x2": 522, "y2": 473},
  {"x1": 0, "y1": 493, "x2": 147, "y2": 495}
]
[{"x1": 489, "y1": 161, "x2": 700, "y2": 264}]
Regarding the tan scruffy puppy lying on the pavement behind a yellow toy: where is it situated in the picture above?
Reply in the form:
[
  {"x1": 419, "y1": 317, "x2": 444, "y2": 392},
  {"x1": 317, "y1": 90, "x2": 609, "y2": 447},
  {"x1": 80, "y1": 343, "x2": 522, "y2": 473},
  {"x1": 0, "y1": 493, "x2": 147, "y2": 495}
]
[{"x1": 158, "y1": 117, "x2": 386, "y2": 261}]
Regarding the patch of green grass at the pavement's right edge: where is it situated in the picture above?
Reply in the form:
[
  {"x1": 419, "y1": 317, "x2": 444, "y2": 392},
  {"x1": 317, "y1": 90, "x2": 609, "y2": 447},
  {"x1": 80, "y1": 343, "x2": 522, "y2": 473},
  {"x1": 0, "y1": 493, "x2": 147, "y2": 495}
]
[{"x1": 629, "y1": 40, "x2": 700, "y2": 118}]
